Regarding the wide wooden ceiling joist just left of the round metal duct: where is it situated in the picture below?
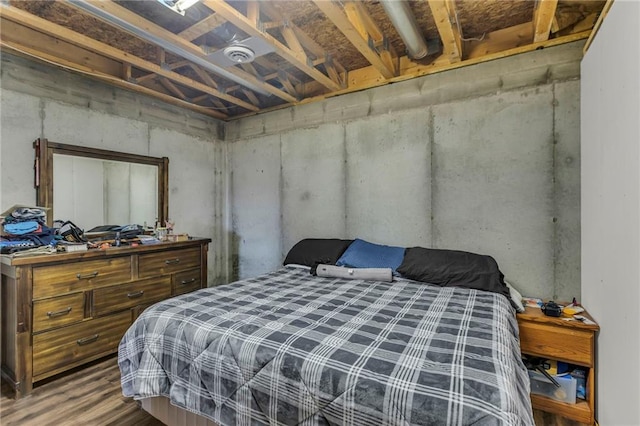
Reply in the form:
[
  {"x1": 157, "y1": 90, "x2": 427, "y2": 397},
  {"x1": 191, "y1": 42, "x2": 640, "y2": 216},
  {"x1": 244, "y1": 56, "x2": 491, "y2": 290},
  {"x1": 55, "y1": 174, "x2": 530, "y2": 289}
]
[{"x1": 313, "y1": 0, "x2": 395, "y2": 79}]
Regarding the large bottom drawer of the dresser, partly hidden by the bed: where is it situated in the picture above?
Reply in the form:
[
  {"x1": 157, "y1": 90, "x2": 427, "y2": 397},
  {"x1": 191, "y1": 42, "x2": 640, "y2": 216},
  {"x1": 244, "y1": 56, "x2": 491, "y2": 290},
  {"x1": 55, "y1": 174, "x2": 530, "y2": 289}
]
[{"x1": 33, "y1": 311, "x2": 131, "y2": 377}]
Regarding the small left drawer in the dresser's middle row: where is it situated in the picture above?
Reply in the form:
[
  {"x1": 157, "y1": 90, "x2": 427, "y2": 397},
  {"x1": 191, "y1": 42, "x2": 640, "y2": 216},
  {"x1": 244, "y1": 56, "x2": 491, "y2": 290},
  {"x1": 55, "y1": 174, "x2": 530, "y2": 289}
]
[{"x1": 33, "y1": 292, "x2": 84, "y2": 333}]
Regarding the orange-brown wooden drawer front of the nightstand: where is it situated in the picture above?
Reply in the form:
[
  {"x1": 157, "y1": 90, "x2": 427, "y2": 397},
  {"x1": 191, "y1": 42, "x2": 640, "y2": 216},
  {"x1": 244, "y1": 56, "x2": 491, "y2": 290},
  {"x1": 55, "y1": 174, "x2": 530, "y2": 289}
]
[{"x1": 519, "y1": 322, "x2": 594, "y2": 366}]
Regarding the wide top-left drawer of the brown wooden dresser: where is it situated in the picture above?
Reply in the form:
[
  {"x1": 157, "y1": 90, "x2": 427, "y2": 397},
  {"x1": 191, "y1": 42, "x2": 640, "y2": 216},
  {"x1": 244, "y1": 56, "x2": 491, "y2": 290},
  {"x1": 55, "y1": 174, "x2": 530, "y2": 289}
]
[{"x1": 33, "y1": 256, "x2": 131, "y2": 299}]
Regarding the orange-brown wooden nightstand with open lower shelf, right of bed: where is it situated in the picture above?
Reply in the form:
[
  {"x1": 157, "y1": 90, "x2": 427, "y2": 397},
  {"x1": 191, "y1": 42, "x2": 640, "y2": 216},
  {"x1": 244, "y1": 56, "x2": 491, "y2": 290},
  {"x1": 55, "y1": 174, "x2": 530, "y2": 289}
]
[{"x1": 518, "y1": 308, "x2": 600, "y2": 425}]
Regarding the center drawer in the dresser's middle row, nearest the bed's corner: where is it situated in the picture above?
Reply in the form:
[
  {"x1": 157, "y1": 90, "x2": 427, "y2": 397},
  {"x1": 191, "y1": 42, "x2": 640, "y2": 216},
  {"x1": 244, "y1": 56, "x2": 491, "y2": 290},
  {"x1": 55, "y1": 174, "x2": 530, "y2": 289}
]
[{"x1": 93, "y1": 276, "x2": 171, "y2": 316}]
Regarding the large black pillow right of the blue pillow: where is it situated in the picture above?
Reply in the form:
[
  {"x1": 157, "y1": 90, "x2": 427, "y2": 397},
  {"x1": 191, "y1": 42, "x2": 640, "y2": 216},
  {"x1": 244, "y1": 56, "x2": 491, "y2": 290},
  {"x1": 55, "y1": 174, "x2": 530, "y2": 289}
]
[{"x1": 398, "y1": 247, "x2": 510, "y2": 298}]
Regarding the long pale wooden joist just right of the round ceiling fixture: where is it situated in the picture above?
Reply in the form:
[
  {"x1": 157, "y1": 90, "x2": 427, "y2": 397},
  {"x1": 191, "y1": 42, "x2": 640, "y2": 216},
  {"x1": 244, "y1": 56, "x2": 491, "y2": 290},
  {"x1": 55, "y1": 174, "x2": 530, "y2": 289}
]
[{"x1": 202, "y1": 0, "x2": 340, "y2": 92}]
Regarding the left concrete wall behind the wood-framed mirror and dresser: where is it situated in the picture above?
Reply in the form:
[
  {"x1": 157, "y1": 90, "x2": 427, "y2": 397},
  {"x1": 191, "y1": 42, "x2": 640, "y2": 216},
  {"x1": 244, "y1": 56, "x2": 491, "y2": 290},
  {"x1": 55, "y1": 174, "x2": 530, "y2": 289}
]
[{"x1": 0, "y1": 54, "x2": 227, "y2": 284}]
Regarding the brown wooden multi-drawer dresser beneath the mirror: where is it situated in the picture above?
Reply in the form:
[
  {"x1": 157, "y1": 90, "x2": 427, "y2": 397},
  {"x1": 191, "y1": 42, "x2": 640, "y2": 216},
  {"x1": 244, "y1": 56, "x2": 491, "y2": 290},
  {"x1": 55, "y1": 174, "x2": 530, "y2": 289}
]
[{"x1": 0, "y1": 238, "x2": 211, "y2": 398}]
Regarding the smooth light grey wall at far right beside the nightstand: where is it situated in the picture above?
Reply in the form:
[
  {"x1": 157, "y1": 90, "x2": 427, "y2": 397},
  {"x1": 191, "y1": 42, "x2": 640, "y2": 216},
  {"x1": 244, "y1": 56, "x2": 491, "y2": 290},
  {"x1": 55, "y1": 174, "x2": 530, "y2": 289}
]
[{"x1": 581, "y1": 1, "x2": 640, "y2": 426}]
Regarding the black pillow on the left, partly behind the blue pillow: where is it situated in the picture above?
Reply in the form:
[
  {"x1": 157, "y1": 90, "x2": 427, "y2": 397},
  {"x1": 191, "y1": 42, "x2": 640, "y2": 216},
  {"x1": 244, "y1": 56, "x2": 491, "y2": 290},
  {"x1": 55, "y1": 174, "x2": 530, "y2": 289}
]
[{"x1": 284, "y1": 238, "x2": 353, "y2": 266}]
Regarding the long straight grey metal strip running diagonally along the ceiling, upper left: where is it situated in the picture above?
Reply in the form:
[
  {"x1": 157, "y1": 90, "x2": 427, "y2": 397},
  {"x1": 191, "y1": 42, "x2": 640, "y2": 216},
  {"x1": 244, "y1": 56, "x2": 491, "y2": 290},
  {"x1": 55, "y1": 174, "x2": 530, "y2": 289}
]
[{"x1": 69, "y1": 0, "x2": 270, "y2": 96}]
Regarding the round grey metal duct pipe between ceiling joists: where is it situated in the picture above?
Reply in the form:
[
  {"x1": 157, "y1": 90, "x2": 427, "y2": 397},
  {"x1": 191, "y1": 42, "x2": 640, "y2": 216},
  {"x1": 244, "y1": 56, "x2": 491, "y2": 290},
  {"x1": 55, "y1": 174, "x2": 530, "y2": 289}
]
[{"x1": 380, "y1": 0, "x2": 429, "y2": 59}]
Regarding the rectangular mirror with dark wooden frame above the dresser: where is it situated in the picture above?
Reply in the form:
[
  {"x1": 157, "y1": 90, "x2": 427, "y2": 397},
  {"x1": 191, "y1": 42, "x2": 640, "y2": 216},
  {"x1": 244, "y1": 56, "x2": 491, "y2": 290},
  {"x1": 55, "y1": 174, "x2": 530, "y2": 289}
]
[{"x1": 34, "y1": 139, "x2": 169, "y2": 231}]
